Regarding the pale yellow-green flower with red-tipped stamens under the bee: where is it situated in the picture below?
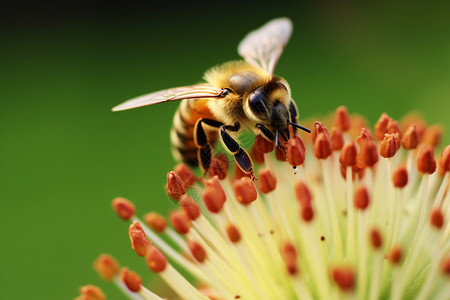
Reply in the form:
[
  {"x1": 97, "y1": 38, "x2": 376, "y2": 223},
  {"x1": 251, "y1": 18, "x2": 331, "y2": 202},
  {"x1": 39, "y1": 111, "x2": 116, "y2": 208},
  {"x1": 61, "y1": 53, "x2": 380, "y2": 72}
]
[{"x1": 76, "y1": 107, "x2": 450, "y2": 300}]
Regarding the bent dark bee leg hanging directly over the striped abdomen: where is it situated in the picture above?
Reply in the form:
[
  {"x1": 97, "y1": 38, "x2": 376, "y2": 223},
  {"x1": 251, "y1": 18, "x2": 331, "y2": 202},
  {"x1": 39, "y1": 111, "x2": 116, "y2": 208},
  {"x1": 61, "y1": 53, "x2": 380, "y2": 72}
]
[{"x1": 194, "y1": 119, "x2": 223, "y2": 172}]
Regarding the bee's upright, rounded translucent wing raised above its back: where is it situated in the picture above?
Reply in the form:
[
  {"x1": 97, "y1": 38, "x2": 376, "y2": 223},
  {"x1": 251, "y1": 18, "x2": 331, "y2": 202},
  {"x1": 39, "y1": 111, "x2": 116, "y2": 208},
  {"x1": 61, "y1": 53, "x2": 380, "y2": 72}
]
[{"x1": 238, "y1": 18, "x2": 292, "y2": 74}]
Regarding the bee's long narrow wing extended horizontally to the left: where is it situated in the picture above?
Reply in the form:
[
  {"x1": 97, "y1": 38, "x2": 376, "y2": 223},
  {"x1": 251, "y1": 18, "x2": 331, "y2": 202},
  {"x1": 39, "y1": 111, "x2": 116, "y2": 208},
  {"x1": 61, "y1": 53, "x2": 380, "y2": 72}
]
[{"x1": 112, "y1": 83, "x2": 223, "y2": 111}]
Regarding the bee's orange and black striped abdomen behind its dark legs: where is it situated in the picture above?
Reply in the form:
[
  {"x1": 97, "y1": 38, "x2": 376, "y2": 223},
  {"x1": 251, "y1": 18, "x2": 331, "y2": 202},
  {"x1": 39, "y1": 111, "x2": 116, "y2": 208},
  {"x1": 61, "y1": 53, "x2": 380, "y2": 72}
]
[{"x1": 170, "y1": 99, "x2": 217, "y2": 166}]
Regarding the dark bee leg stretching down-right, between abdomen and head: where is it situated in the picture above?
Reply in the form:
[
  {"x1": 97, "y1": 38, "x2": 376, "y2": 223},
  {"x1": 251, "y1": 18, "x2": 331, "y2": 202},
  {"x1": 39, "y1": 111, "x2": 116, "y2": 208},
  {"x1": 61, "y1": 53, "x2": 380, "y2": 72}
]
[{"x1": 220, "y1": 123, "x2": 254, "y2": 178}]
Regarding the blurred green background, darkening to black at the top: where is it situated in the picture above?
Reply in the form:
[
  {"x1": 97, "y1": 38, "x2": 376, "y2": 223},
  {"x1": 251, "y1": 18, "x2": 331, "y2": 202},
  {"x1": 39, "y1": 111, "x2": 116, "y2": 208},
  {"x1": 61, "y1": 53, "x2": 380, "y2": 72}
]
[{"x1": 0, "y1": 0, "x2": 450, "y2": 299}]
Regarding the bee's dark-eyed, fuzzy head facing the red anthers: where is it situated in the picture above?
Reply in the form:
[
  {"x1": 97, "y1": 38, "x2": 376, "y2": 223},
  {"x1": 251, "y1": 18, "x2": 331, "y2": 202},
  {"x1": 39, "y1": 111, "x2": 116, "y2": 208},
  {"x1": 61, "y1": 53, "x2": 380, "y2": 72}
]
[{"x1": 247, "y1": 80, "x2": 291, "y2": 129}]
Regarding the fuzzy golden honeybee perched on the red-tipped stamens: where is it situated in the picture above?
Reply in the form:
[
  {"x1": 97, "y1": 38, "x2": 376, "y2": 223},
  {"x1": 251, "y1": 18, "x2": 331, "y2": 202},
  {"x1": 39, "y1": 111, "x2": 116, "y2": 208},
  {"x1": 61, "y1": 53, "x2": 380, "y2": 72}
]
[{"x1": 112, "y1": 18, "x2": 310, "y2": 178}]
